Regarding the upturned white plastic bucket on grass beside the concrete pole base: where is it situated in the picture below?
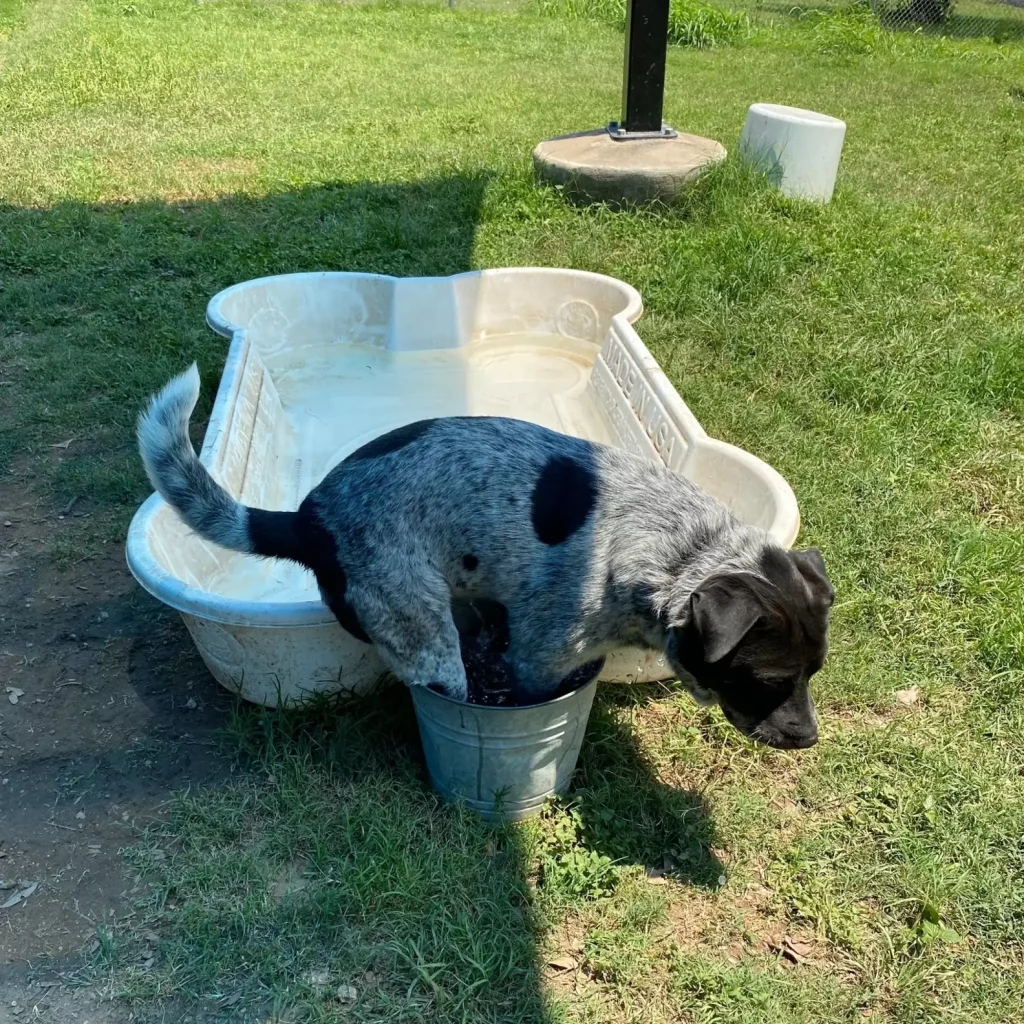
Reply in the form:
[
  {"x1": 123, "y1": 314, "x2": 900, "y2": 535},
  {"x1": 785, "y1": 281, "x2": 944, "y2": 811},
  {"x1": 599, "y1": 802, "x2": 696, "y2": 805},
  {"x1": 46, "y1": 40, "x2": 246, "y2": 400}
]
[{"x1": 739, "y1": 103, "x2": 846, "y2": 203}]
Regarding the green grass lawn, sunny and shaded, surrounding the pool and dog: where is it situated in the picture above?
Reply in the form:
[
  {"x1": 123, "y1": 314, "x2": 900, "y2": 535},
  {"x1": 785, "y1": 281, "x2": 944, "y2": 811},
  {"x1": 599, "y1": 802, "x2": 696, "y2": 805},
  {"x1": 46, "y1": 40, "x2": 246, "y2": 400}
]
[{"x1": 0, "y1": 0, "x2": 1024, "y2": 1024}]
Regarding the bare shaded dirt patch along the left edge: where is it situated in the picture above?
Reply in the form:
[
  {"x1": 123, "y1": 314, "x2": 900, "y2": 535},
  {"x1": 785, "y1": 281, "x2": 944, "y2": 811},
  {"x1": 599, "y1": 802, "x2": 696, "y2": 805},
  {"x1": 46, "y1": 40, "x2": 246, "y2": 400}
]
[{"x1": 0, "y1": 485, "x2": 229, "y2": 1024}]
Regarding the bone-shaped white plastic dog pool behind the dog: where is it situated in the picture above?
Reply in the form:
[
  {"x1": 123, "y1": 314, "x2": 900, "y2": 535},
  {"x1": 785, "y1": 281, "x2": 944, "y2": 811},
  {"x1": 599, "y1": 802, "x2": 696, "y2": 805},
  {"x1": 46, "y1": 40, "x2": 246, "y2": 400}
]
[{"x1": 127, "y1": 268, "x2": 800, "y2": 705}]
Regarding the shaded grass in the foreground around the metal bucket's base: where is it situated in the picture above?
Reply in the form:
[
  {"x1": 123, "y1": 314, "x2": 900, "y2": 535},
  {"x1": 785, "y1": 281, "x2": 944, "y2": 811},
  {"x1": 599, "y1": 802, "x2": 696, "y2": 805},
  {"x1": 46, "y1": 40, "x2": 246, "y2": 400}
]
[{"x1": 115, "y1": 684, "x2": 721, "y2": 1024}]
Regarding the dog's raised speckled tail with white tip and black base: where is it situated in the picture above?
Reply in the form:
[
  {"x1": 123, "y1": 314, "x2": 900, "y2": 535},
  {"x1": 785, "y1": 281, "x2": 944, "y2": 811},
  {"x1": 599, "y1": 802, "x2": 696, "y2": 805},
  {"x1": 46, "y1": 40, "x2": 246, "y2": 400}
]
[{"x1": 138, "y1": 362, "x2": 306, "y2": 564}]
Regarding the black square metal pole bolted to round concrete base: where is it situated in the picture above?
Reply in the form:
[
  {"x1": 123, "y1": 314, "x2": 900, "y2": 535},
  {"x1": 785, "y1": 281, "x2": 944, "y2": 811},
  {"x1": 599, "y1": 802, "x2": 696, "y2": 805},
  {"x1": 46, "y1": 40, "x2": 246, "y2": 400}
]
[{"x1": 612, "y1": 0, "x2": 675, "y2": 138}]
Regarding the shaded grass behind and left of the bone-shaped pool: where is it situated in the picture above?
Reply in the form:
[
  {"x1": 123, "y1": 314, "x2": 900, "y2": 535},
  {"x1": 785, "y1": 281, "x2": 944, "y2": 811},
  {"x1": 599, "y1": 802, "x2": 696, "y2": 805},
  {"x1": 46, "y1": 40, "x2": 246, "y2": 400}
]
[{"x1": 0, "y1": 172, "x2": 489, "y2": 483}]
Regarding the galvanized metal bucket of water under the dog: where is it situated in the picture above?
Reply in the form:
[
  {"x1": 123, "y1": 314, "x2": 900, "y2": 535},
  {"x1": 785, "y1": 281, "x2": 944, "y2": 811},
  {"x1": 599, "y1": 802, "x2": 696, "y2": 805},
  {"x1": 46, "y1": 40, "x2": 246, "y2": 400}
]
[{"x1": 412, "y1": 680, "x2": 597, "y2": 821}]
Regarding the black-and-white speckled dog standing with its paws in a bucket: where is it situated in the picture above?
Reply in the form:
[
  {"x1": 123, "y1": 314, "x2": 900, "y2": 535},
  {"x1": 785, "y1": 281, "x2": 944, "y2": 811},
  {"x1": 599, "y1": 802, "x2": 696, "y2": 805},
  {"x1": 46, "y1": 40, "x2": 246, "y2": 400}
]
[{"x1": 138, "y1": 364, "x2": 835, "y2": 749}]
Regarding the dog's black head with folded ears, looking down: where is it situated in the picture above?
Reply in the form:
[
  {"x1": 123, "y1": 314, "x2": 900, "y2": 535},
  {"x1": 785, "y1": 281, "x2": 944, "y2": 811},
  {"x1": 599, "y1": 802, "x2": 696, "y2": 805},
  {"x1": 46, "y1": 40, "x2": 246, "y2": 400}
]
[{"x1": 666, "y1": 547, "x2": 836, "y2": 750}]
